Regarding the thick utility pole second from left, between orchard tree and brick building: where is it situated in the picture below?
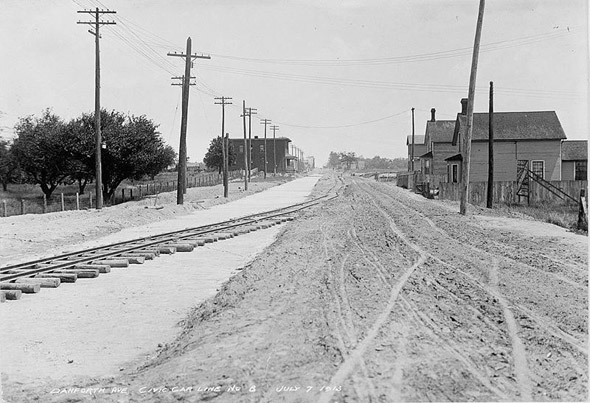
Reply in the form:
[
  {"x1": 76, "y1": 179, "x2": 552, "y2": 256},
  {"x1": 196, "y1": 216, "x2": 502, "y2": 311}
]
[{"x1": 168, "y1": 36, "x2": 211, "y2": 204}]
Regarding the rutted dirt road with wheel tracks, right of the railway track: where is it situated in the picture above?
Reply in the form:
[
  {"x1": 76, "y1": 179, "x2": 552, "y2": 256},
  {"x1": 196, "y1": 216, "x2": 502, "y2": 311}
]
[{"x1": 5, "y1": 177, "x2": 588, "y2": 402}]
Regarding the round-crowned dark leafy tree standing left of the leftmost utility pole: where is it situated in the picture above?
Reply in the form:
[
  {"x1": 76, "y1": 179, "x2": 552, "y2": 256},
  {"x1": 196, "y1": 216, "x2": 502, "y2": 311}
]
[{"x1": 11, "y1": 109, "x2": 70, "y2": 198}]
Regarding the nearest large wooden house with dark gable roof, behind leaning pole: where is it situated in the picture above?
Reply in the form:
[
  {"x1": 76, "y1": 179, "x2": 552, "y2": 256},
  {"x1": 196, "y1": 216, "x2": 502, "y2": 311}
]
[{"x1": 447, "y1": 99, "x2": 566, "y2": 182}]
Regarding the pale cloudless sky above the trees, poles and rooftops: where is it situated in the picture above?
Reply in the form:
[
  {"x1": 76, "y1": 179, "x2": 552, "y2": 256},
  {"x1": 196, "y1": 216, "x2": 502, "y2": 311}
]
[{"x1": 0, "y1": 0, "x2": 589, "y2": 165}]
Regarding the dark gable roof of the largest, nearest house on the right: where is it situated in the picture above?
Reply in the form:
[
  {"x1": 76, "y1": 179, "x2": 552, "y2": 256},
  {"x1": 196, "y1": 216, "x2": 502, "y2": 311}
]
[{"x1": 453, "y1": 111, "x2": 566, "y2": 144}]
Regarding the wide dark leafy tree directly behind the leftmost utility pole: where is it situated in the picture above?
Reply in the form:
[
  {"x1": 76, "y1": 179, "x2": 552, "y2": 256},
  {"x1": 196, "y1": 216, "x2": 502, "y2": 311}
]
[{"x1": 68, "y1": 110, "x2": 176, "y2": 200}]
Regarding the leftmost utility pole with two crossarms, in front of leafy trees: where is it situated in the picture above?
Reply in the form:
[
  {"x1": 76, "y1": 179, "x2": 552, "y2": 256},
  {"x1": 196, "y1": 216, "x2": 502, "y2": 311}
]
[{"x1": 78, "y1": 7, "x2": 117, "y2": 210}]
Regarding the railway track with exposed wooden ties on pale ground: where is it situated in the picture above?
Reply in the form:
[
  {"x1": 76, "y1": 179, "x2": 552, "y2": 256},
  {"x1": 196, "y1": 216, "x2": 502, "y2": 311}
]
[{"x1": 0, "y1": 194, "x2": 336, "y2": 302}]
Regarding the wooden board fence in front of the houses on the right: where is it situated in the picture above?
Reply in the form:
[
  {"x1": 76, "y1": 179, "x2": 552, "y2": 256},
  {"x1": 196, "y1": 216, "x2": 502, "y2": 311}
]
[{"x1": 438, "y1": 181, "x2": 588, "y2": 206}]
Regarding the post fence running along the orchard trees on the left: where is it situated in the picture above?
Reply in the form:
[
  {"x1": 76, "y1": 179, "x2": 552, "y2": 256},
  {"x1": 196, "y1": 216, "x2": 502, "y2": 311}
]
[{"x1": 0, "y1": 171, "x2": 243, "y2": 217}]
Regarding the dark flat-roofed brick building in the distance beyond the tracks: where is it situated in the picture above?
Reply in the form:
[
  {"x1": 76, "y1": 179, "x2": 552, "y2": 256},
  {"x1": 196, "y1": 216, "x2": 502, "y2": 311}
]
[{"x1": 230, "y1": 136, "x2": 297, "y2": 174}]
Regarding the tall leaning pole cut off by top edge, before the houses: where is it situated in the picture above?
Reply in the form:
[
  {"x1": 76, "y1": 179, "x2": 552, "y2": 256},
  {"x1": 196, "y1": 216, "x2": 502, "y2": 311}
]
[{"x1": 459, "y1": 0, "x2": 486, "y2": 215}]
